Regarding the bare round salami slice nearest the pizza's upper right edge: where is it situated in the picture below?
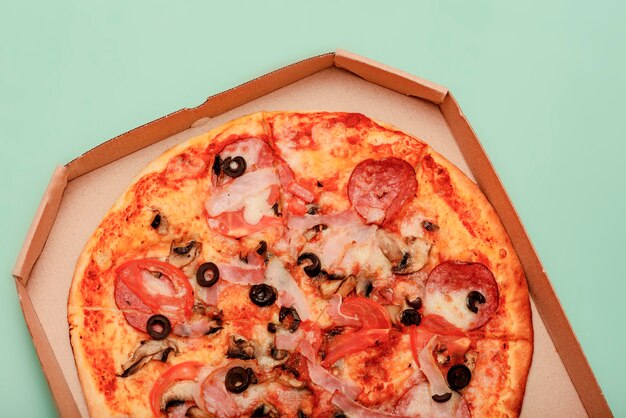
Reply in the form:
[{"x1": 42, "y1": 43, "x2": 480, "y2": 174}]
[{"x1": 348, "y1": 157, "x2": 417, "y2": 225}]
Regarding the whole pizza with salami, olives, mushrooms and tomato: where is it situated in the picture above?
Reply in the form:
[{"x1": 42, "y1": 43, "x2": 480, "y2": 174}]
[{"x1": 68, "y1": 112, "x2": 533, "y2": 418}]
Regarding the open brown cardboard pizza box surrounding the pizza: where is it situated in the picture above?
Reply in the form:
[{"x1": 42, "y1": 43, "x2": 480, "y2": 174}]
[{"x1": 13, "y1": 50, "x2": 612, "y2": 417}]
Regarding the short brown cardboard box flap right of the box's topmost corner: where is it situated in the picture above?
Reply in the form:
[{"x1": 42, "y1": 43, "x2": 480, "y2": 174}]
[{"x1": 335, "y1": 49, "x2": 448, "y2": 104}]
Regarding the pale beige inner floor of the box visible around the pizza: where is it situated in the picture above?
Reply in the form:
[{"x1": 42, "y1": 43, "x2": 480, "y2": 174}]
[{"x1": 28, "y1": 68, "x2": 587, "y2": 417}]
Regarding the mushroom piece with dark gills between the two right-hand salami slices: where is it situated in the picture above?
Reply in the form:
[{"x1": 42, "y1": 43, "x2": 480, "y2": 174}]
[{"x1": 376, "y1": 229, "x2": 432, "y2": 274}]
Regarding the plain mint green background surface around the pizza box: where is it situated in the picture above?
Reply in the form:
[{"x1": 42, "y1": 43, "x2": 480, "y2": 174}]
[{"x1": 0, "y1": 0, "x2": 626, "y2": 417}]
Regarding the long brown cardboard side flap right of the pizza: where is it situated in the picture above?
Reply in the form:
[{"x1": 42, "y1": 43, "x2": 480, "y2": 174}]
[{"x1": 440, "y1": 93, "x2": 612, "y2": 417}]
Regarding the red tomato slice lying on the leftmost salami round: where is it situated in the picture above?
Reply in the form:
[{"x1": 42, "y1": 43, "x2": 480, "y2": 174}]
[{"x1": 116, "y1": 259, "x2": 193, "y2": 321}]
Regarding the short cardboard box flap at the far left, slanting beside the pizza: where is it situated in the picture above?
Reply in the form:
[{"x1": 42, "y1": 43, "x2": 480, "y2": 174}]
[{"x1": 13, "y1": 167, "x2": 67, "y2": 286}]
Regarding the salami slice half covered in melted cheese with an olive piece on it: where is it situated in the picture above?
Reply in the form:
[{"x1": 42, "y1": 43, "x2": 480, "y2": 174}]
[{"x1": 424, "y1": 261, "x2": 499, "y2": 331}]
